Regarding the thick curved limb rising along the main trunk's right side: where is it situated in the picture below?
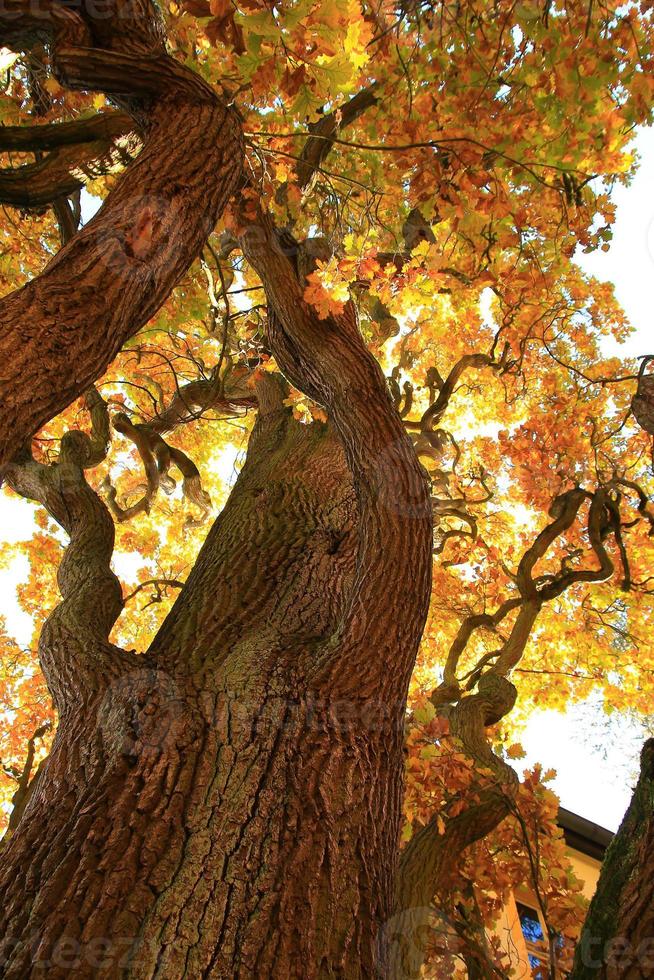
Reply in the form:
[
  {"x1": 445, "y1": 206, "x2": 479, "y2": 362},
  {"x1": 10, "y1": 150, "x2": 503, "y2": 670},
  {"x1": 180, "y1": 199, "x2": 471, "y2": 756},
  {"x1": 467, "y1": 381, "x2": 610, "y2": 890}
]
[{"x1": 240, "y1": 212, "x2": 432, "y2": 698}]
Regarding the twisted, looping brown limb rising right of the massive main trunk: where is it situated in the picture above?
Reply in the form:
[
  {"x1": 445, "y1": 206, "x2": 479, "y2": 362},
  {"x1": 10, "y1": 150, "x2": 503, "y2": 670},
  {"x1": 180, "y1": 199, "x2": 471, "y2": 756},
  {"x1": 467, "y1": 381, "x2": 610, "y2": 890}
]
[{"x1": 396, "y1": 487, "x2": 636, "y2": 969}]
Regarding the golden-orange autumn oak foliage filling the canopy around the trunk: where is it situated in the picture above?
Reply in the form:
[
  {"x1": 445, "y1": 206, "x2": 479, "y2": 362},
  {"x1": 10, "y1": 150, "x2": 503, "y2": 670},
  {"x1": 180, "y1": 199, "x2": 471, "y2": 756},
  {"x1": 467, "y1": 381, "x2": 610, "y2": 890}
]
[{"x1": 0, "y1": 0, "x2": 654, "y2": 976}]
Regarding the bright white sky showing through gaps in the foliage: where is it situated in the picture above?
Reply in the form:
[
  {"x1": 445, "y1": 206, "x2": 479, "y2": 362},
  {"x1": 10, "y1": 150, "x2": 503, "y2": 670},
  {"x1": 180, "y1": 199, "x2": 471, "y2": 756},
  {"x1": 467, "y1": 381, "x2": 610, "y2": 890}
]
[{"x1": 0, "y1": 130, "x2": 654, "y2": 830}]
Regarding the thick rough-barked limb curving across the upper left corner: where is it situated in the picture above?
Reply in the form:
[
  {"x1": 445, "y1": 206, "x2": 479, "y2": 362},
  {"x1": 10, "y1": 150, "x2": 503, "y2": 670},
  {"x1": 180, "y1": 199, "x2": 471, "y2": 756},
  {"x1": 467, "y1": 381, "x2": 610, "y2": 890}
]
[{"x1": 0, "y1": 0, "x2": 243, "y2": 465}]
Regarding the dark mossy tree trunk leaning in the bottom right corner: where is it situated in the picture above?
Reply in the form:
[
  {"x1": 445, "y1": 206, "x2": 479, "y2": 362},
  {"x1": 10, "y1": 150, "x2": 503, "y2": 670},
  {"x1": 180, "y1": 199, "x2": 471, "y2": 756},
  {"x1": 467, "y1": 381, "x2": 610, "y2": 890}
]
[{"x1": 570, "y1": 739, "x2": 654, "y2": 980}]
